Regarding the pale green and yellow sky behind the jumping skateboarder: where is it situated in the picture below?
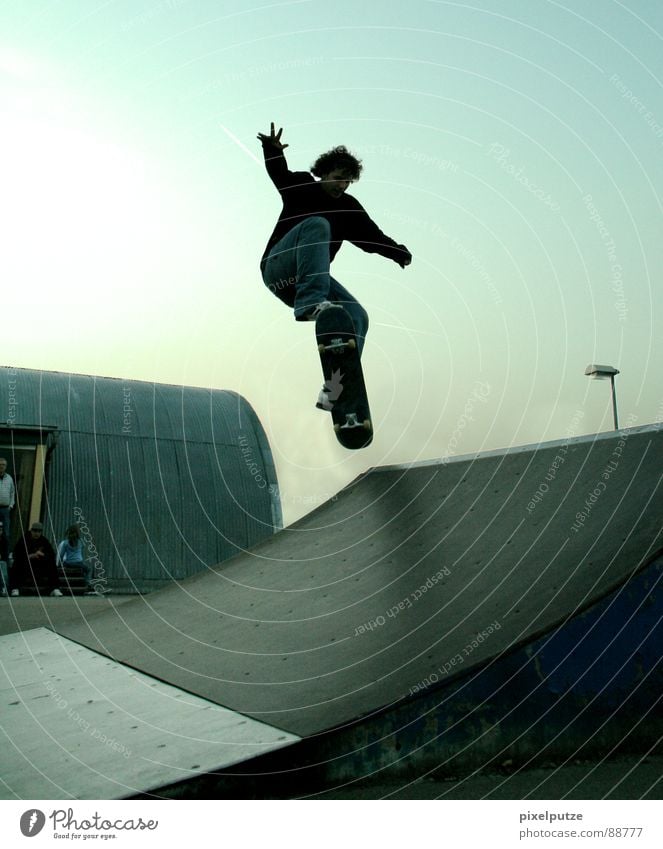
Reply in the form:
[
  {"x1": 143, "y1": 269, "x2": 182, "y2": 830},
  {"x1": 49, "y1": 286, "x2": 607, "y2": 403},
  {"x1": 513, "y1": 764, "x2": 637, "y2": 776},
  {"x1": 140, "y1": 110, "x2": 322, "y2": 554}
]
[{"x1": 0, "y1": 0, "x2": 663, "y2": 521}]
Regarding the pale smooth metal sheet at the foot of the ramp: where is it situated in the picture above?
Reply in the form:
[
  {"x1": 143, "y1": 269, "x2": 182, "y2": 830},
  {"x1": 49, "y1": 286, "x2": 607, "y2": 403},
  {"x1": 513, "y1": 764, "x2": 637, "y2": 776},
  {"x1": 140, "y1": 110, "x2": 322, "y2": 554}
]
[{"x1": 0, "y1": 628, "x2": 297, "y2": 799}]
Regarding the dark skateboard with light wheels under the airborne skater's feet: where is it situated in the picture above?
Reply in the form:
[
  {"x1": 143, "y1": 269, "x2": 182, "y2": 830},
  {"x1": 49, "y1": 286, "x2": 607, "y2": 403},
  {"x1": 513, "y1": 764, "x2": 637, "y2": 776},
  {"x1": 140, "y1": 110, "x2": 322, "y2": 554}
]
[{"x1": 315, "y1": 306, "x2": 373, "y2": 450}]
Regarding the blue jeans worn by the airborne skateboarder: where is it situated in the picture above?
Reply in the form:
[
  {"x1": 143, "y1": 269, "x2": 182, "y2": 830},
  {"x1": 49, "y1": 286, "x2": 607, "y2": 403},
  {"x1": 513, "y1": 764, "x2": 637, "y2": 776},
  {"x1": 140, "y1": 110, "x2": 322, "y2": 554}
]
[{"x1": 262, "y1": 215, "x2": 368, "y2": 354}]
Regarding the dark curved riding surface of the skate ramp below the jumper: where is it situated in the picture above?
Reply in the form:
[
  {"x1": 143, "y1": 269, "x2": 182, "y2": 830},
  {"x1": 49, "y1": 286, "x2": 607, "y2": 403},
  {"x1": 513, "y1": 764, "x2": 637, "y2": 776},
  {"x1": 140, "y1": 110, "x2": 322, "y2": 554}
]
[{"x1": 58, "y1": 426, "x2": 663, "y2": 738}]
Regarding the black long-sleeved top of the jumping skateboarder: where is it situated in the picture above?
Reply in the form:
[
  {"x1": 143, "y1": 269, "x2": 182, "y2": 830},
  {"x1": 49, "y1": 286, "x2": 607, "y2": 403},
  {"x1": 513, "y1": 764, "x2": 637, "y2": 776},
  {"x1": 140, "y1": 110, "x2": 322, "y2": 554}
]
[{"x1": 261, "y1": 144, "x2": 408, "y2": 263}]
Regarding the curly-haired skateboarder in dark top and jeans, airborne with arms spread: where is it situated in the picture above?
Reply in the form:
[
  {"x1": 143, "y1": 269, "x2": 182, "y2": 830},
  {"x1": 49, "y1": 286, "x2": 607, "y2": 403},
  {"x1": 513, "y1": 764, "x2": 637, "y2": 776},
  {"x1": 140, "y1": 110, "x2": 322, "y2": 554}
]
[{"x1": 258, "y1": 124, "x2": 412, "y2": 409}]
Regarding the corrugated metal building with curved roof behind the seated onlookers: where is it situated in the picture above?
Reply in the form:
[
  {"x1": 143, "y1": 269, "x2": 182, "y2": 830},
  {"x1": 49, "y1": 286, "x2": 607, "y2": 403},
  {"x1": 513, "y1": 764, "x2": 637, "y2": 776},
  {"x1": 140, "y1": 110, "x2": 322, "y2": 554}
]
[{"x1": 0, "y1": 367, "x2": 282, "y2": 592}]
